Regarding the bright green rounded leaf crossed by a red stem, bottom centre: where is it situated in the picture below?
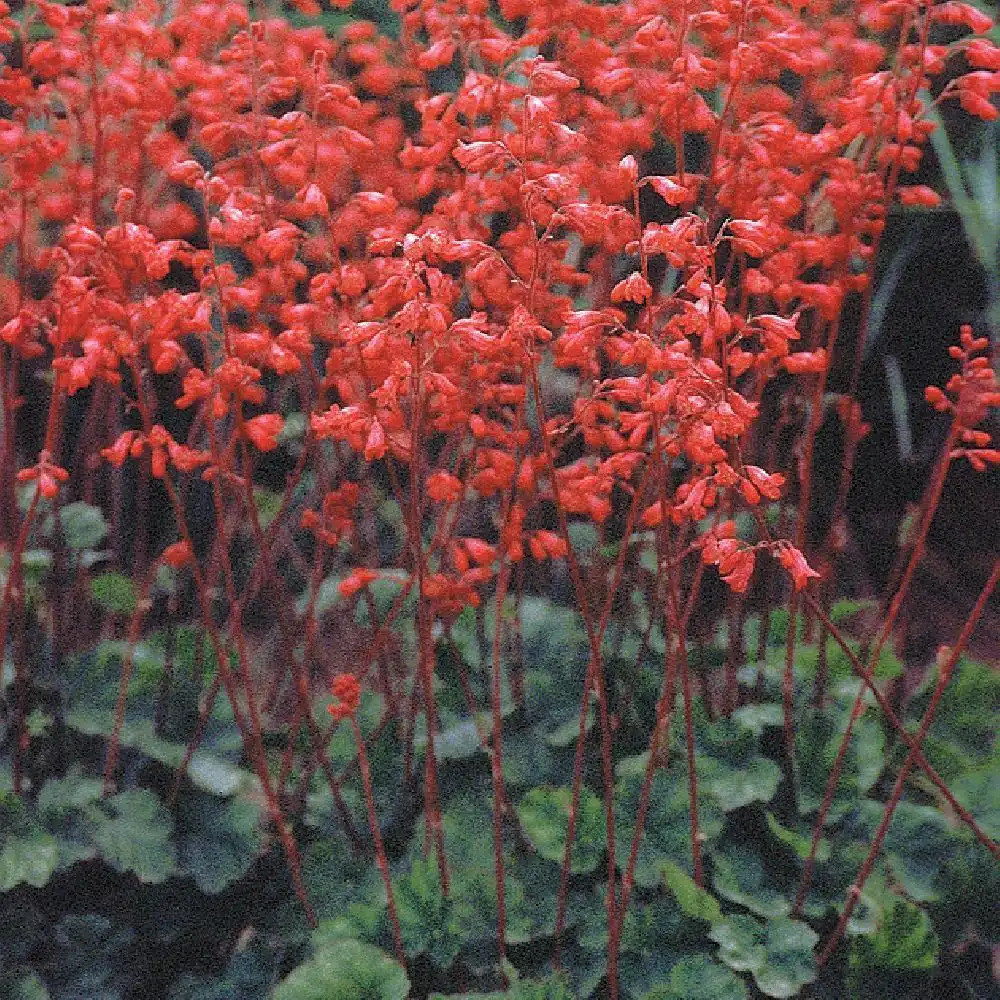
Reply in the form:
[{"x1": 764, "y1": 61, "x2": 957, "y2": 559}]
[{"x1": 517, "y1": 787, "x2": 605, "y2": 874}]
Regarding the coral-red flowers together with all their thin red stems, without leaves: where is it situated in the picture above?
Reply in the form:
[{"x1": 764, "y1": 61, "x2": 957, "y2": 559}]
[{"x1": 0, "y1": 0, "x2": 1000, "y2": 997}]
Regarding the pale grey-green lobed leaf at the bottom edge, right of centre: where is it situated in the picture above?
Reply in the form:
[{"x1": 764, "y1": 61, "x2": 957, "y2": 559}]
[{"x1": 708, "y1": 914, "x2": 819, "y2": 998}]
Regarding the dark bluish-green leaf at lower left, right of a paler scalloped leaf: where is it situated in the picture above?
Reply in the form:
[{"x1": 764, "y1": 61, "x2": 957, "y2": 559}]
[{"x1": 177, "y1": 792, "x2": 262, "y2": 894}]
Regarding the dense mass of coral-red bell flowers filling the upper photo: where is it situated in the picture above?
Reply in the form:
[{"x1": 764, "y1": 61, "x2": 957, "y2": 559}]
[{"x1": 0, "y1": 0, "x2": 1000, "y2": 606}]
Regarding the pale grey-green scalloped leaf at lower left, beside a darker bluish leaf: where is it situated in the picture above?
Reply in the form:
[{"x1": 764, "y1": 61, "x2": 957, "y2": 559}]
[{"x1": 94, "y1": 788, "x2": 177, "y2": 883}]
